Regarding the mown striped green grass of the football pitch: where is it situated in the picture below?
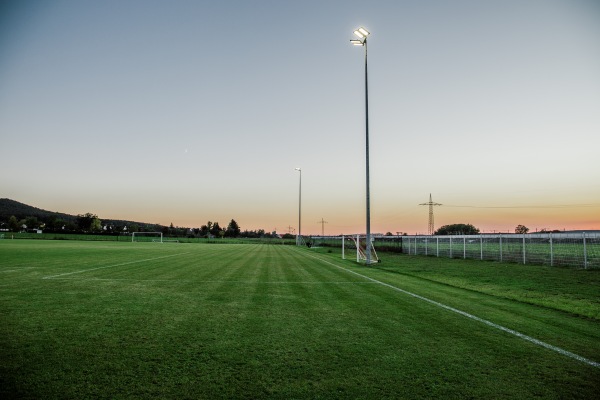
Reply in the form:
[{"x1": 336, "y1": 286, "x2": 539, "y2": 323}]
[{"x1": 0, "y1": 240, "x2": 600, "y2": 399}]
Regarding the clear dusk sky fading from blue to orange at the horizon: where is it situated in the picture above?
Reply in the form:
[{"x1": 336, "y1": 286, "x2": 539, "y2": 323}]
[{"x1": 0, "y1": 0, "x2": 600, "y2": 235}]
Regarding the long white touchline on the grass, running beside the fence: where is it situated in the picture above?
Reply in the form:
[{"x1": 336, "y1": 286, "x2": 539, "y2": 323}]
[{"x1": 308, "y1": 254, "x2": 600, "y2": 368}]
